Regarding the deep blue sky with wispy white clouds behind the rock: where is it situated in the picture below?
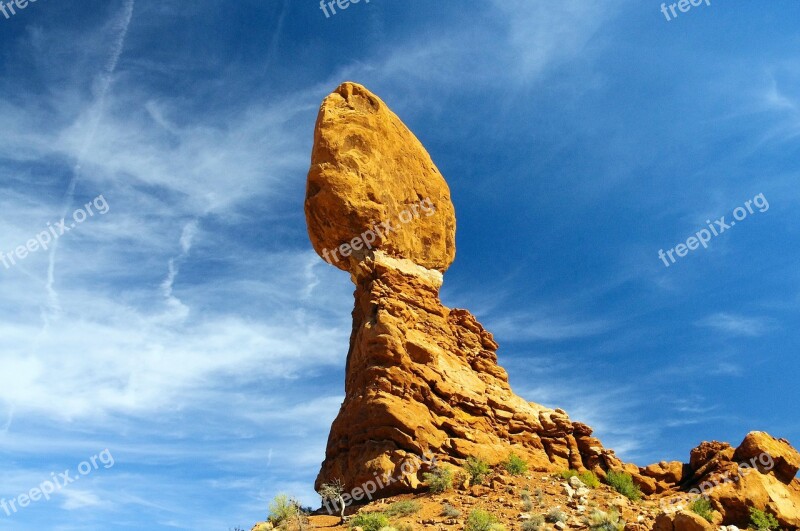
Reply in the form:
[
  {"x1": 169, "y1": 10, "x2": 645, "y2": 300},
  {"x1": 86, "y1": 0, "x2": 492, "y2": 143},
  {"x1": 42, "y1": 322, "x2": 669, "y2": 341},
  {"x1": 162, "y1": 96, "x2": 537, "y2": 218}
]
[{"x1": 0, "y1": 0, "x2": 800, "y2": 531}]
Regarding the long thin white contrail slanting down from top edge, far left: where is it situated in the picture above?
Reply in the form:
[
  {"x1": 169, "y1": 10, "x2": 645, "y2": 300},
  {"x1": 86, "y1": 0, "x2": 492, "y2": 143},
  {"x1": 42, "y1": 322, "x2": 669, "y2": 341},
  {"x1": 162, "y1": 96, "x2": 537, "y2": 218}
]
[{"x1": 43, "y1": 0, "x2": 136, "y2": 328}]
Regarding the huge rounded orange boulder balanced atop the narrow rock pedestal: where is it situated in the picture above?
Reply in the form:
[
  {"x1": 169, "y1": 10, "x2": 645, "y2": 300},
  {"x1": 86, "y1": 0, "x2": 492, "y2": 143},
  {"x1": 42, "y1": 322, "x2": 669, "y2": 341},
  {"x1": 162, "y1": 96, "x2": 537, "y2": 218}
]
[{"x1": 305, "y1": 83, "x2": 456, "y2": 272}]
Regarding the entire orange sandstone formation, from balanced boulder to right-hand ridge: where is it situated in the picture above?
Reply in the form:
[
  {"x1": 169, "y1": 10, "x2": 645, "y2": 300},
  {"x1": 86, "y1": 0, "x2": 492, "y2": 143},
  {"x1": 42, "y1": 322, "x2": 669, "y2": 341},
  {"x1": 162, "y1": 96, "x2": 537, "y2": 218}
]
[{"x1": 305, "y1": 83, "x2": 800, "y2": 526}]
